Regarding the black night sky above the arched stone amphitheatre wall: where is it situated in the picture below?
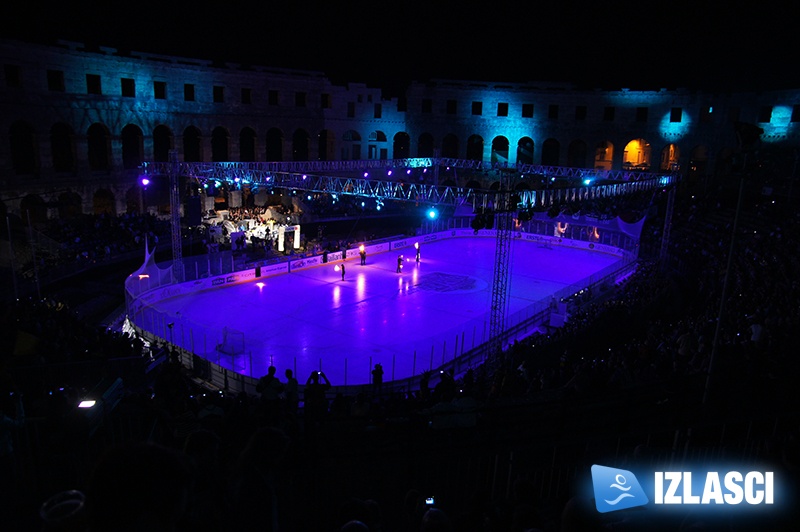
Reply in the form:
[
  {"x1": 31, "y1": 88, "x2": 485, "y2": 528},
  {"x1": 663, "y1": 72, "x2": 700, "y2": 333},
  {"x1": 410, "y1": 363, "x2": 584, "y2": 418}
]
[{"x1": 0, "y1": 0, "x2": 800, "y2": 93}]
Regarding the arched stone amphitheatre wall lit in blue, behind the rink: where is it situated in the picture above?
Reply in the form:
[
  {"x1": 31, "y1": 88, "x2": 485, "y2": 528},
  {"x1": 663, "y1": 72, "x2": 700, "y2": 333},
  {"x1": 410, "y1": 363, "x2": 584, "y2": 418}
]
[{"x1": 0, "y1": 41, "x2": 800, "y2": 219}]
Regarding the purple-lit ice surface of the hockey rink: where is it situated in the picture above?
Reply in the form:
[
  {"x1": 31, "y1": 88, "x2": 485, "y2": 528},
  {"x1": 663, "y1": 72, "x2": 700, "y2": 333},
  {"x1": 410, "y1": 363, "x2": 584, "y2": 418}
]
[{"x1": 144, "y1": 237, "x2": 622, "y2": 385}]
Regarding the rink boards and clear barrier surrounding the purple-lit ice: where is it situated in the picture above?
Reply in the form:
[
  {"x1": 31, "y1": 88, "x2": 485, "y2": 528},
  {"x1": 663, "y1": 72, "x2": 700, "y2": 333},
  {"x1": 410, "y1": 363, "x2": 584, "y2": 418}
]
[{"x1": 127, "y1": 218, "x2": 637, "y2": 393}]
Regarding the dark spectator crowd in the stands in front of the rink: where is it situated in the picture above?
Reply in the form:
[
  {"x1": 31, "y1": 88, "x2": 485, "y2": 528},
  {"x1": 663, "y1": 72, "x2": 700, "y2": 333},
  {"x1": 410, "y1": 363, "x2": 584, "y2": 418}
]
[{"x1": 0, "y1": 177, "x2": 800, "y2": 532}]
